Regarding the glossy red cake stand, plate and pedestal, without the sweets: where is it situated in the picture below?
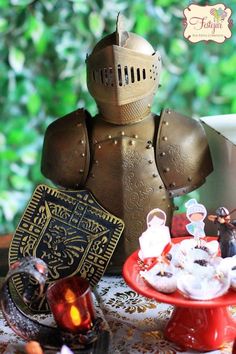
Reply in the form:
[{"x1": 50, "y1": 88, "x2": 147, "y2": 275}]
[{"x1": 123, "y1": 237, "x2": 236, "y2": 352}]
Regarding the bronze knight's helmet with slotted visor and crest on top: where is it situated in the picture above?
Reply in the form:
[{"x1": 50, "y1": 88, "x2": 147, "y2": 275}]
[{"x1": 86, "y1": 14, "x2": 161, "y2": 124}]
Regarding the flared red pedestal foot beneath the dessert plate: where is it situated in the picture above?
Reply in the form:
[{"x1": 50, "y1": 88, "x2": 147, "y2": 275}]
[{"x1": 165, "y1": 307, "x2": 236, "y2": 351}]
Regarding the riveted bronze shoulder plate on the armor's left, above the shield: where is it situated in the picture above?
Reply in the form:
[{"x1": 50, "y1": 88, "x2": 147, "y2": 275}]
[{"x1": 41, "y1": 109, "x2": 91, "y2": 188}]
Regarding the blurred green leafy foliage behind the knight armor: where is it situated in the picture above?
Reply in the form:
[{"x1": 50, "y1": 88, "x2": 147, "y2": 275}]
[{"x1": 0, "y1": 0, "x2": 236, "y2": 233}]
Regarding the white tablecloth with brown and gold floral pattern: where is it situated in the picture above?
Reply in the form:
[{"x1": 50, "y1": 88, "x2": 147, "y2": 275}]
[{"x1": 0, "y1": 276, "x2": 236, "y2": 354}]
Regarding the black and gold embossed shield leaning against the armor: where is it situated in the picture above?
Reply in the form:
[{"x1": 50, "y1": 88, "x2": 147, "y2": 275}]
[{"x1": 9, "y1": 185, "x2": 124, "y2": 312}]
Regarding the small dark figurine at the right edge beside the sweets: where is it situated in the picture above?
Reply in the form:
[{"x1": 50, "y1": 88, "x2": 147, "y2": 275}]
[{"x1": 208, "y1": 207, "x2": 236, "y2": 258}]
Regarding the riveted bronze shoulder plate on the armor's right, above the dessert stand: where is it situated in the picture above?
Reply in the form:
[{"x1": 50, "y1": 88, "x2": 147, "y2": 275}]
[{"x1": 156, "y1": 109, "x2": 213, "y2": 197}]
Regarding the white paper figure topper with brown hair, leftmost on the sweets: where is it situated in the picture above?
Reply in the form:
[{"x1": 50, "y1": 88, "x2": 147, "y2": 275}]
[{"x1": 139, "y1": 208, "x2": 171, "y2": 260}]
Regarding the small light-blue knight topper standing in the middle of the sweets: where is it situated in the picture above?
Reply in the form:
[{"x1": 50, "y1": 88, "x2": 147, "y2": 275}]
[{"x1": 185, "y1": 199, "x2": 207, "y2": 241}]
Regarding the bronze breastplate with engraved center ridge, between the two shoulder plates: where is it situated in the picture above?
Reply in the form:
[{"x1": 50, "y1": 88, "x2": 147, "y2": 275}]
[{"x1": 86, "y1": 116, "x2": 172, "y2": 273}]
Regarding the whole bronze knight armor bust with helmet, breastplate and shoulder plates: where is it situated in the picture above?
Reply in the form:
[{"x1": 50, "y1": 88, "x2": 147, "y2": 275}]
[{"x1": 42, "y1": 16, "x2": 212, "y2": 273}]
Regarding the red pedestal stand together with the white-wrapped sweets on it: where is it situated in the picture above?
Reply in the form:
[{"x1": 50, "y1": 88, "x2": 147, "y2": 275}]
[{"x1": 123, "y1": 201, "x2": 236, "y2": 352}]
